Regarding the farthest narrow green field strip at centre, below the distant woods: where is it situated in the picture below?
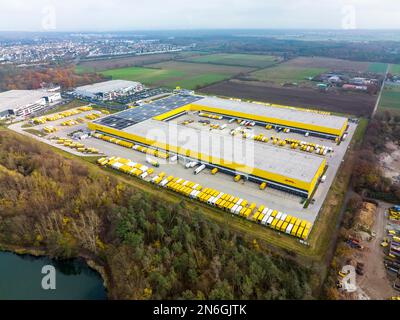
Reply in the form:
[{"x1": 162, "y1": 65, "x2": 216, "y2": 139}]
[{"x1": 185, "y1": 53, "x2": 279, "y2": 68}]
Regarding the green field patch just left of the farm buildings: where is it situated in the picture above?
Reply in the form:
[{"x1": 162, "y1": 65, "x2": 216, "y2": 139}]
[{"x1": 250, "y1": 64, "x2": 328, "y2": 84}]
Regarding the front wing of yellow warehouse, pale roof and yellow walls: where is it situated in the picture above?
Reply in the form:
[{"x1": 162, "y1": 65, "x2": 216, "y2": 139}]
[{"x1": 90, "y1": 119, "x2": 326, "y2": 197}]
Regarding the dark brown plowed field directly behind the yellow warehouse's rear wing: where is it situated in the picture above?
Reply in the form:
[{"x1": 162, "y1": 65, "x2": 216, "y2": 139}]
[{"x1": 200, "y1": 80, "x2": 377, "y2": 116}]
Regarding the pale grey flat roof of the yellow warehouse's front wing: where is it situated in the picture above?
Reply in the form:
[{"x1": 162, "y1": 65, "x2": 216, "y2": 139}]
[{"x1": 122, "y1": 119, "x2": 325, "y2": 182}]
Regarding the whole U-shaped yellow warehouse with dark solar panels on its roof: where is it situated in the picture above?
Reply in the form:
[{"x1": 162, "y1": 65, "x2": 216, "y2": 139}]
[{"x1": 85, "y1": 95, "x2": 347, "y2": 198}]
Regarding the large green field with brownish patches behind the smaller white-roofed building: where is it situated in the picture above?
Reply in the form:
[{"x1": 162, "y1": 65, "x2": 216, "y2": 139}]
[{"x1": 102, "y1": 61, "x2": 252, "y2": 89}]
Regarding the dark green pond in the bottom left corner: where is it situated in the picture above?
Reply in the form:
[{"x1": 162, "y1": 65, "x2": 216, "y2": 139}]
[{"x1": 0, "y1": 252, "x2": 107, "y2": 300}]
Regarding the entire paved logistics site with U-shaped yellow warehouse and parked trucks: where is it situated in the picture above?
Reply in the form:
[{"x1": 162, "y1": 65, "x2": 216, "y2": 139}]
[{"x1": 10, "y1": 93, "x2": 357, "y2": 243}]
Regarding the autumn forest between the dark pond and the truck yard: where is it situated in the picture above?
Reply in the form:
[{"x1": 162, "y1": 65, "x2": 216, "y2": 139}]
[{"x1": 0, "y1": 128, "x2": 312, "y2": 299}]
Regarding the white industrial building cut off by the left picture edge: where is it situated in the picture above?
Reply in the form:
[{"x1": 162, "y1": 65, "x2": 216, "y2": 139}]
[{"x1": 0, "y1": 88, "x2": 61, "y2": 118}]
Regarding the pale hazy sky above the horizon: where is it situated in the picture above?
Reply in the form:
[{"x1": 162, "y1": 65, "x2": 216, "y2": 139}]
[{"x1": 0, "y1": 0, "x2": 400, "y2": 31}]
